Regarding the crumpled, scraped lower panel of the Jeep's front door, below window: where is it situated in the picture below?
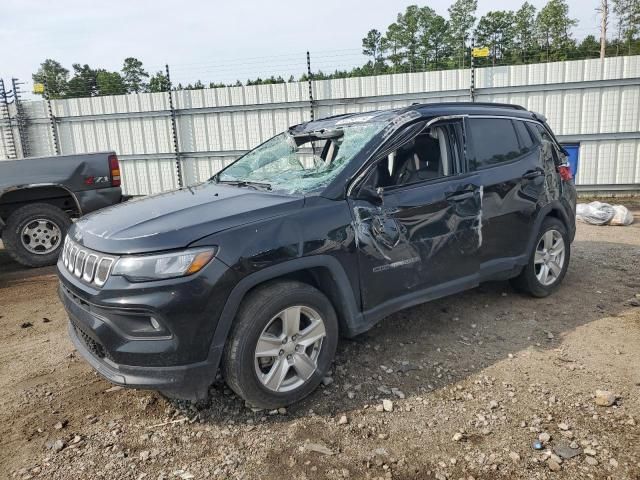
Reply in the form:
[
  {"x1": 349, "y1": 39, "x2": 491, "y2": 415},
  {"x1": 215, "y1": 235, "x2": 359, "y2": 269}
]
[{"x1": 350, "y1": 175, "x2": 482, "y2": 310}]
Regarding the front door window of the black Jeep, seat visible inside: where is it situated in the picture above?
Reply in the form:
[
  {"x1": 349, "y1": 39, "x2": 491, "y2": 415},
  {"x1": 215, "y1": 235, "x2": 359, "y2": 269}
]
[{"x1": 370, "y1": 124, "x2": 459, "y2": 188}]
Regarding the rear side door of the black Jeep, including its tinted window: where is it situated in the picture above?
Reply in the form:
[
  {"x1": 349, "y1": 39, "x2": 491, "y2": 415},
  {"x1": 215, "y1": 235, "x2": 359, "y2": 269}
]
[{"x1": 467, "y1": 117, "x2": 545, "y2": 274}]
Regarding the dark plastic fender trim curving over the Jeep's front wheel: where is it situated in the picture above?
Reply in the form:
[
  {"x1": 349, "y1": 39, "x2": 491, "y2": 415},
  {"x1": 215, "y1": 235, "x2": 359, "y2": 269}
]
[{"x1": 211, "y1": 255, "x2": 362, "y2": 351}]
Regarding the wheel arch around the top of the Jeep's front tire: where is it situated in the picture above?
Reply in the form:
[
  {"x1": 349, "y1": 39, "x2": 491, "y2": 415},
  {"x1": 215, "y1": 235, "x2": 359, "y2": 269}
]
[{"x1": 211, "y1": 255, "x2": 362, "y2": 349}]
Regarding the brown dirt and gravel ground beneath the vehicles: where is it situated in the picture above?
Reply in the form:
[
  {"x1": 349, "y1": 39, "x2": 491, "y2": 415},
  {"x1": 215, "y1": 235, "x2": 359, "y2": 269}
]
[{"x1": 0, "y1": 205, "x2": 640, "y2": 480}]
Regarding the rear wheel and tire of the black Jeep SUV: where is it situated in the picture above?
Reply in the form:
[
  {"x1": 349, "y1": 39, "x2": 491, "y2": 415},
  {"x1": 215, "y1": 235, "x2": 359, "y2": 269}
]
[{"x1": 511, "y1": 217, "x2": 571, "y2": 298}]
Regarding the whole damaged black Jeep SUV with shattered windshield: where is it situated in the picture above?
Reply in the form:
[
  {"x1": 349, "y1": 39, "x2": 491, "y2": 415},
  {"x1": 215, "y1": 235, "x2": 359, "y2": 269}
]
[{"x1": 58, "y1": 103, "x2": 576, "y2": 408}]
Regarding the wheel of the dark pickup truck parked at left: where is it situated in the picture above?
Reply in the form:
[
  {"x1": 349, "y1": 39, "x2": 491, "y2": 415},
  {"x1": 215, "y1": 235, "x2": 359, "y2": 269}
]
[{"x1": 2, "y1": 203, "x2": 71, "y2": 267}]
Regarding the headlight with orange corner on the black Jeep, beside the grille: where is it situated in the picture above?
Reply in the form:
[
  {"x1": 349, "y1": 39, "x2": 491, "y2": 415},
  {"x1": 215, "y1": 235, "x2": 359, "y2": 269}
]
[{"x1": 111, "y1": 247, "x2": 217, "y2": 282}]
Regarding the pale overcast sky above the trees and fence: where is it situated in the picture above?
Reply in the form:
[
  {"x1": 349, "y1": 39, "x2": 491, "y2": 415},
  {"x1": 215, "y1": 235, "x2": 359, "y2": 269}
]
[{"x1": 0, "y1": 0, "x2": 599, "y2": 95}]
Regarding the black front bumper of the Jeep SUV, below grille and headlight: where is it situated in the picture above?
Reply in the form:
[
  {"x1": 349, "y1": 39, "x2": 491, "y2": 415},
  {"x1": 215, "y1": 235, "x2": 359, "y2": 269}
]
[{"x1": 58, "y1": 251, "x2": 234, "y2": 400}]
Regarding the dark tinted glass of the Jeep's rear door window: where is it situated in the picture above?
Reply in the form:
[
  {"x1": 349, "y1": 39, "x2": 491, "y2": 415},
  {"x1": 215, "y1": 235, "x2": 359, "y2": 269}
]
[{"x1": 468, "y1": 118, "x2": 522, "y2": 170}]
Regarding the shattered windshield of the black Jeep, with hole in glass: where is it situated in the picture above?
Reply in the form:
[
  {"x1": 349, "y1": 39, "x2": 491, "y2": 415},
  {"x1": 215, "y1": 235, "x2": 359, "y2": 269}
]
[{"x1": 214, "y1": 122, "x2": 386, "y2": 194}]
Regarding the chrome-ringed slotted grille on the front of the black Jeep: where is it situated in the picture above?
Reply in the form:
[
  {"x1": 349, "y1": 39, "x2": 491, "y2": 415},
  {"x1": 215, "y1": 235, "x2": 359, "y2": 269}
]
[{"x1": 61, "y1": 236, "x2": 117, "y2": 287}]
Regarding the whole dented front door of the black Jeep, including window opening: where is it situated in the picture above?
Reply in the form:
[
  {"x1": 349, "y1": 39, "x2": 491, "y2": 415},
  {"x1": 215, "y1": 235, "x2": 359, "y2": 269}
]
[{"x1": 349, "y1": 121, "x2": 482, "y2": 311}]
